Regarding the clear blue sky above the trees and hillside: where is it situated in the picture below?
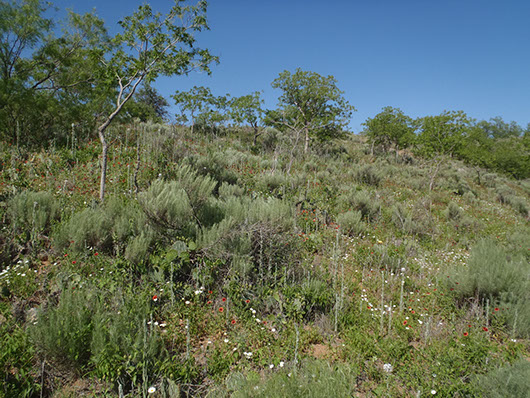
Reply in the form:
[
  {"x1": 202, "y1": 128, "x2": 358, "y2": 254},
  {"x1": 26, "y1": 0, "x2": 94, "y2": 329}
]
[{"x1": 54, "y1": 0, "x2": 530, "y2": 132}]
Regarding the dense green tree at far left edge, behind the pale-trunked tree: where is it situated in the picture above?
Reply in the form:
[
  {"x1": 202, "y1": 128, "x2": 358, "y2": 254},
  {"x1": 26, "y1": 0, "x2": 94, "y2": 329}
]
[{"x1": 0, "y1": 0, "x2": 109, "y2": 145}]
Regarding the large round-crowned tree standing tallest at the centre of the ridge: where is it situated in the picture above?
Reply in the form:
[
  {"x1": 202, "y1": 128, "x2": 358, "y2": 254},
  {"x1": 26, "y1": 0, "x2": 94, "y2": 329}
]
[{"x1": 268, "y1": 68, "x2": 355, "y2": 153}]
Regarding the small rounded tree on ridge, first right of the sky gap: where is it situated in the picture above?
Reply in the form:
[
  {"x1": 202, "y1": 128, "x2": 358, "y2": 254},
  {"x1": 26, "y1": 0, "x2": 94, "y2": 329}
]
[{"x1": 363, "y1": 106, "x2": 415, "y2": 157}]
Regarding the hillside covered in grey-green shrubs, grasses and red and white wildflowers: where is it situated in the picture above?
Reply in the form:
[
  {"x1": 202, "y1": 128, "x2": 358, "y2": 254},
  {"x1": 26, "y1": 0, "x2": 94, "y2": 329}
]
[{"x1": 0, "y1": 125, "x2": 530, "y2": 397}]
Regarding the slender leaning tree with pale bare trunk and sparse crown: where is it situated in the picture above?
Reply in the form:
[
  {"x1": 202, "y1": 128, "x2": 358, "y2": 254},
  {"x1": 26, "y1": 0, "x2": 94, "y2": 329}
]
[{"x1": 98, "y1": 0, "x2": 217, "y2": 201}]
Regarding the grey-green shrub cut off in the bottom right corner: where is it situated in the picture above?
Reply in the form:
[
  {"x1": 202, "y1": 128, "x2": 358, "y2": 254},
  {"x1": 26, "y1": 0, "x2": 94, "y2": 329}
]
[{"x1": 475, "y1": 359, "x2": 530, "y2": 398}]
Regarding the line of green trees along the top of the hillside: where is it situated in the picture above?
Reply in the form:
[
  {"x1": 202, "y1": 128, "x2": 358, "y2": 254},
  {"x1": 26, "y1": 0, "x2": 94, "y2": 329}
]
[{"x1": 0, "y1": 0, "x2": 530, "y2": 194}]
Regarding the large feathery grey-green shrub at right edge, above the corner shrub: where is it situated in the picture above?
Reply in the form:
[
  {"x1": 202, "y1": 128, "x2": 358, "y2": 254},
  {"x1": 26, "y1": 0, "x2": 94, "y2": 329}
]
[{"x1": 448, "y1": 240, "x2": 530, "y2": 336}]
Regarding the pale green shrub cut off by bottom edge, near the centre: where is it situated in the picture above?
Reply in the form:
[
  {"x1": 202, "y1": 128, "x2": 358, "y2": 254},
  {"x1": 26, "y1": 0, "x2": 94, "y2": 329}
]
[{"x1": 217, "y1": 360, "x2": 357, "y2": 398}]
